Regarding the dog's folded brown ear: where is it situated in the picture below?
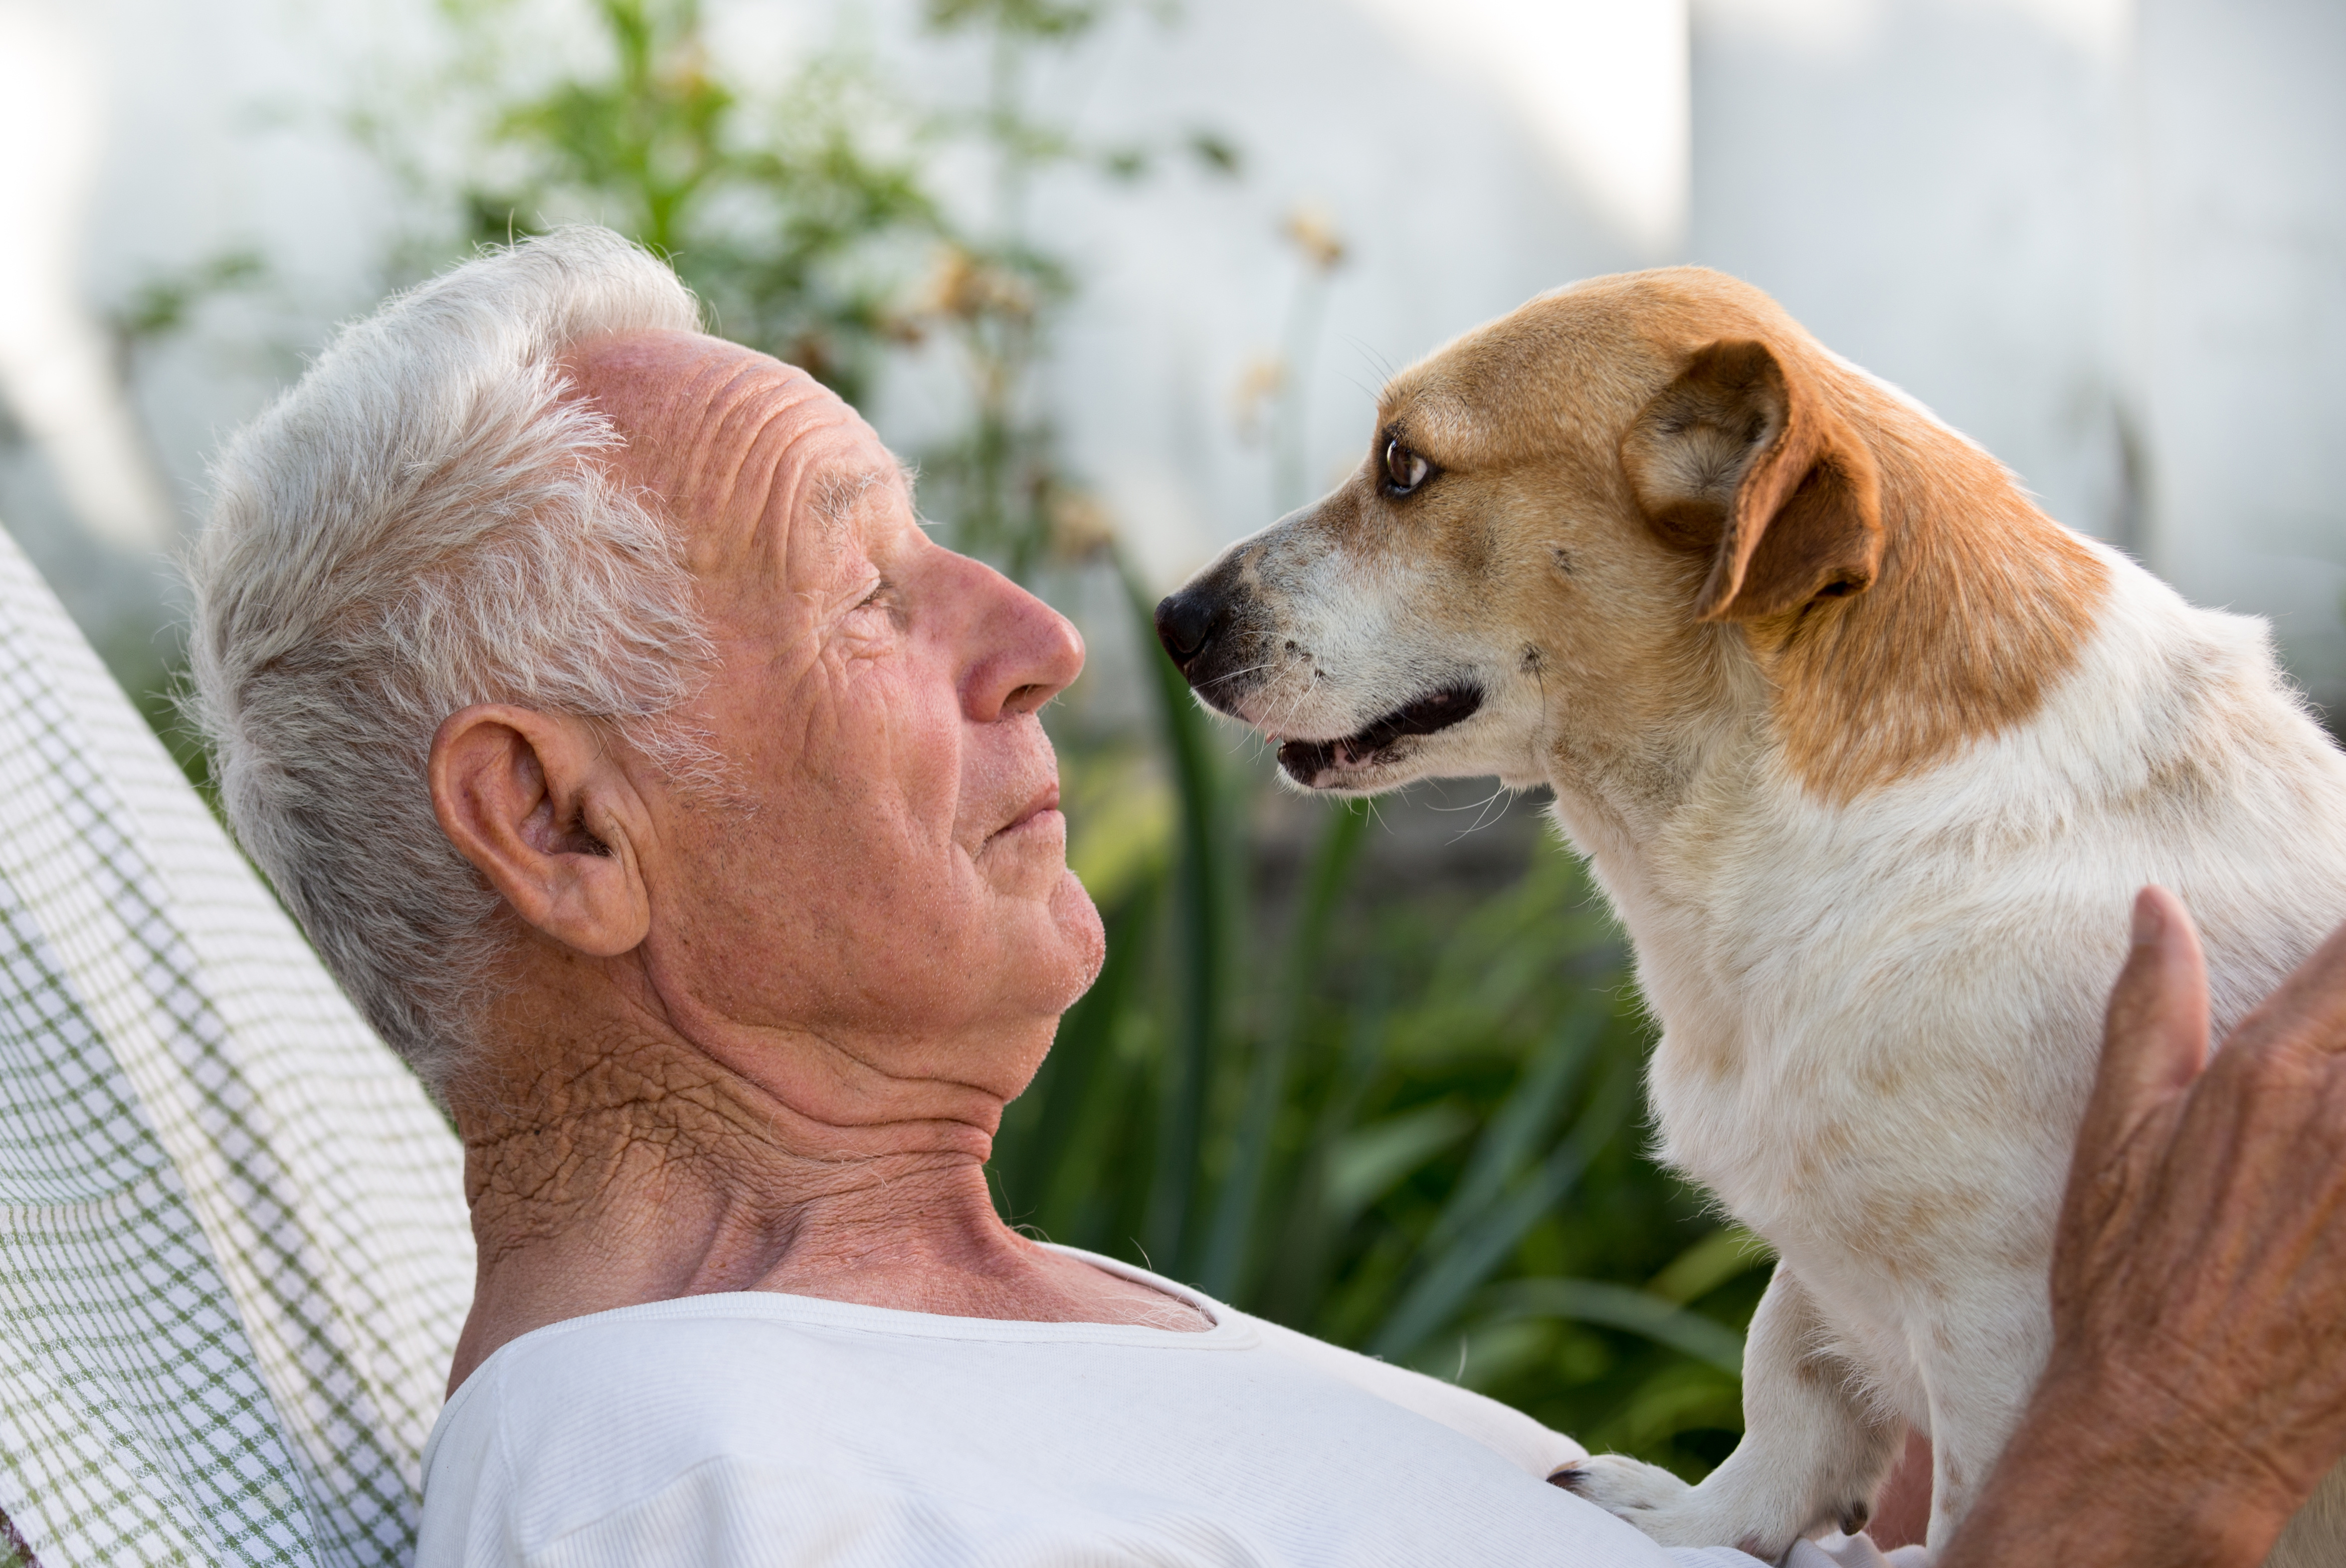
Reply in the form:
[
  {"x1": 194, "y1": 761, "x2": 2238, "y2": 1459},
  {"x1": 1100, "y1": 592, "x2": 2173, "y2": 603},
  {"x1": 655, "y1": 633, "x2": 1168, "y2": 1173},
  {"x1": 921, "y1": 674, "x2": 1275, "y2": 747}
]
[{"x1": 1621, "y1": 338, "x2": 1882, "y2": 620}]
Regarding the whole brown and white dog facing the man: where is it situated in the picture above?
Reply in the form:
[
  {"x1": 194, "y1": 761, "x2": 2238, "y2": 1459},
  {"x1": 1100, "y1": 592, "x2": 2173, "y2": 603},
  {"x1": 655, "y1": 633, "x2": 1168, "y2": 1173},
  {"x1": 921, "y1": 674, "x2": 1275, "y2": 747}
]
[{"x1": 1157, "y1": 268, "x2": 2346, "y2": 1568}]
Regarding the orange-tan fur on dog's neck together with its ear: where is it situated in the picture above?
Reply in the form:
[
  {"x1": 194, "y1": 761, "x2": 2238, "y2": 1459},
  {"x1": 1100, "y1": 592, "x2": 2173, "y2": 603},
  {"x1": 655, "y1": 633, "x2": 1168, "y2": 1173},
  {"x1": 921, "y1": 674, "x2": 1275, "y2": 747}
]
[{"x1": 1621, "y1": 279, "x2": 2109, "y2": 803}]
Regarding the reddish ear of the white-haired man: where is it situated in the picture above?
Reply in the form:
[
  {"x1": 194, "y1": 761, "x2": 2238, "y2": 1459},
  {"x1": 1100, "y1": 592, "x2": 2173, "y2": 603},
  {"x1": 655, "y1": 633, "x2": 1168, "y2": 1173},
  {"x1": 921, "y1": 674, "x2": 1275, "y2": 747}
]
[{"x1": 429, "y1": 702, "x2": 652, "y2": 958}]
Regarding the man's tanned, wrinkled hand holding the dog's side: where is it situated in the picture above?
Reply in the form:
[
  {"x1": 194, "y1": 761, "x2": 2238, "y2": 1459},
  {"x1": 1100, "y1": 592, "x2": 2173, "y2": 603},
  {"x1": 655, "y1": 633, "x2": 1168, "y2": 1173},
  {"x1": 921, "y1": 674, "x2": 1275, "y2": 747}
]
[{"x1": 1940, "y1": 887, "x2": 2346, "y2": 1568}]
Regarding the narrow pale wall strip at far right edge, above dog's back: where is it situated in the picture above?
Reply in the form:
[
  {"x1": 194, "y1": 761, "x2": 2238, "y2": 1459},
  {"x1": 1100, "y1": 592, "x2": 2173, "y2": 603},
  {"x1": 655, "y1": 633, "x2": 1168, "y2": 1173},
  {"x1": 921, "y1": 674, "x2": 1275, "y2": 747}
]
[{"x1": 2130, "y1": 0, "x2": 2346, "y2": 716}]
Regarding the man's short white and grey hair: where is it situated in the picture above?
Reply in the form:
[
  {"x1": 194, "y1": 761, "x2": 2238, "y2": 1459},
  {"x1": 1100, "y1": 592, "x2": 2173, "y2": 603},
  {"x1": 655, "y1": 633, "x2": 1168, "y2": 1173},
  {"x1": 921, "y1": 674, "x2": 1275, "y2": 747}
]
[{"x1": 188, "y1": 228, "x2": 711, "y2": 1092}]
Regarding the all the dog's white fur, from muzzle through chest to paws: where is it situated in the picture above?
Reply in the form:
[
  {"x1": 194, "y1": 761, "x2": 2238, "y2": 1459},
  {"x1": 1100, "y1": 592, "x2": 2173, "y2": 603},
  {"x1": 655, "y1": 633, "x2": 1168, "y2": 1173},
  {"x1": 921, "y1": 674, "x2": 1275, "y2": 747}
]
[{"x1": 1182, "y1": 519, "x2": 2346, "y2": 1568}]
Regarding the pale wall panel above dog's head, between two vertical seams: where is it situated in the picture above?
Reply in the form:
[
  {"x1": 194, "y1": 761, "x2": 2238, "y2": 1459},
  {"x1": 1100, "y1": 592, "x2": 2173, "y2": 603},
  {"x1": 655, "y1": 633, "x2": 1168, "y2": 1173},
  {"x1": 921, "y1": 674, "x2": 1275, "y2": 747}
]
[{"x1": 1689, "y1": 0, "x2": 2140, "y2": 538}]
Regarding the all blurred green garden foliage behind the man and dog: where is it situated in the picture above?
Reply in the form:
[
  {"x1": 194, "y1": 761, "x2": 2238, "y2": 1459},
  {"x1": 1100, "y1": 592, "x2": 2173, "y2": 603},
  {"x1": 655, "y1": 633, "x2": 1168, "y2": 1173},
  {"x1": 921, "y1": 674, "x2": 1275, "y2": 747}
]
[{"x1": 302, "y1": 0, "x2": 1766, "y2": 1476}]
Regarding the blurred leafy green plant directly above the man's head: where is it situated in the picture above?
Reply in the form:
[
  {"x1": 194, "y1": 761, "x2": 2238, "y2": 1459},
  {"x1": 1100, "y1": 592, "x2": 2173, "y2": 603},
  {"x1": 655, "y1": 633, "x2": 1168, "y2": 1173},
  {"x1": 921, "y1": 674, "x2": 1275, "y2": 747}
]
[{"x1": 422, "y1": 0, "x2": 953, "y2": 401}]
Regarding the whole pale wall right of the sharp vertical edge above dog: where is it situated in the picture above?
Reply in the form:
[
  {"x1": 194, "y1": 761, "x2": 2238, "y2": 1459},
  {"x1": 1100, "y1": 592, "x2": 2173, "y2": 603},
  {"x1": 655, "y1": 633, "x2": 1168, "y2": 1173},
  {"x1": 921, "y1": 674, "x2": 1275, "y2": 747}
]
[{"x1": 1689, "y1": 0, "x2": 2346, "y2": 704}]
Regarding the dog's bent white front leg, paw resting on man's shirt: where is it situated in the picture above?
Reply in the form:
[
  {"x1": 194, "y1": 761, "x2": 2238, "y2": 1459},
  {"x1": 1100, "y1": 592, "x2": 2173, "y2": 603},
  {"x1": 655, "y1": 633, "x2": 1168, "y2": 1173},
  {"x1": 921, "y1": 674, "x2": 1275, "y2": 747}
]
[{"x1": 1556, "y1": 1263, "x2": 1903, "y2": 1561}]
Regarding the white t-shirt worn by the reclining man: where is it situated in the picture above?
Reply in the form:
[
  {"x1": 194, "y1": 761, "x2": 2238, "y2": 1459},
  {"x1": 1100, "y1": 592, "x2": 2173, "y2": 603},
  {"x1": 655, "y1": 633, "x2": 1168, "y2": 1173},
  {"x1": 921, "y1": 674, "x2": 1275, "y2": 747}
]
[{"x1": 415, "y1": 1253, "x2": 1867, "y2": 1568}]
